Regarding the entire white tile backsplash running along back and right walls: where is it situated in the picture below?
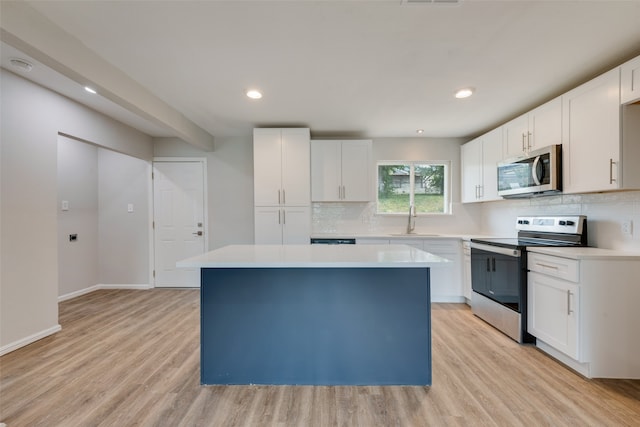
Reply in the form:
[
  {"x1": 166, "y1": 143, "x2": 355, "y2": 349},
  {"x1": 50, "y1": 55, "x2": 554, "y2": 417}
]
[{"x1": 312, "y1": 191, "x2": 640, "y2": 251}]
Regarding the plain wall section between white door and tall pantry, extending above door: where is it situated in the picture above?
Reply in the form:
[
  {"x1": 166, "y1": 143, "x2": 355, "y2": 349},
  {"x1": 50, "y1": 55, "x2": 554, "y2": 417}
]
[{"x1": 154, "y1": 136, "x2": 253, "y2": 250}]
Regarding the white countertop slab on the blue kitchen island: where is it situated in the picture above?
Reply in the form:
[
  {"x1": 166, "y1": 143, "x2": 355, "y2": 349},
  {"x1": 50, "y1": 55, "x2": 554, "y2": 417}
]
[{"x1": 176, "y1": 245, "x2": 451, "y2": 268}]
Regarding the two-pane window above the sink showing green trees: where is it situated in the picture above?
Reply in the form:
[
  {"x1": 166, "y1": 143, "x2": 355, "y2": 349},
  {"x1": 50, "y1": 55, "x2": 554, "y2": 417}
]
[{"x1": 377, "y1": 161, "x2": 450, "y2": 215}]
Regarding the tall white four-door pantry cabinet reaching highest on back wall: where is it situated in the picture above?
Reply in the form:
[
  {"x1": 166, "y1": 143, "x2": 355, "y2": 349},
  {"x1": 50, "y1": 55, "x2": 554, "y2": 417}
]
[{"x1": 253, "y1": 128, "x2": 311, "y2": 244}]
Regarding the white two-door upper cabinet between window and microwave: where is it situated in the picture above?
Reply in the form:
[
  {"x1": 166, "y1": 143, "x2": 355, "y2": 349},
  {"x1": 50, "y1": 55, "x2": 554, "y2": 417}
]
[{"x1": 461, "y1": 128, "x2": 502, "y2": 203}]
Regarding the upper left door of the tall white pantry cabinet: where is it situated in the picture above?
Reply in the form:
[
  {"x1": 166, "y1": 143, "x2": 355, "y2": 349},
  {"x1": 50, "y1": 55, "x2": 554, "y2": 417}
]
[{"x1": 253, "y1": 129, "x2": 282, "y2": 206}]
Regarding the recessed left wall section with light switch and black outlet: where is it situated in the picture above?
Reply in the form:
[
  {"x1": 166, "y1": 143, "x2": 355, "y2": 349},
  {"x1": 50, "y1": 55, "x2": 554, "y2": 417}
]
[{"x1": 57, "y1": 136, "x2": 99, "y2": 296}]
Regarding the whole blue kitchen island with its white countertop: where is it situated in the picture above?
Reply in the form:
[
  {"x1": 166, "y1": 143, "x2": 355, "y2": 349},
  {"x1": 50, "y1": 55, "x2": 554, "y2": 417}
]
[{"x1": 178, "y1": 245, "x2": 448, "y2": 385}]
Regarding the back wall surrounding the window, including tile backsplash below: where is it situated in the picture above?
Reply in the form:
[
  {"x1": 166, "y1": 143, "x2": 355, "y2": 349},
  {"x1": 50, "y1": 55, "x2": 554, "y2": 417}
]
[{"x1": 312, "y1": 138, "x2": 481, "y2": 234}]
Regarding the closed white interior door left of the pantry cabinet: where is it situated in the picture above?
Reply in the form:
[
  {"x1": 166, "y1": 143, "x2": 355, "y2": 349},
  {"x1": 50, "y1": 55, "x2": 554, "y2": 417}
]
[{"x1": 153, "y1": 161, "x2": 206, "y2": 288}]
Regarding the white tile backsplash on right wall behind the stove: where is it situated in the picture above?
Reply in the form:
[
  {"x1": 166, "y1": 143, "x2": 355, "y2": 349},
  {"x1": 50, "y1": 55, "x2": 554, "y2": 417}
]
[{"x1": 481, "y1": 191, "x2": 640, "y2": 251}]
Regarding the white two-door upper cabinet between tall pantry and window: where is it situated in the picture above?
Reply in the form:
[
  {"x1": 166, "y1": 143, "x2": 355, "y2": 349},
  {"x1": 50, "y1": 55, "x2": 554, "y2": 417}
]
[{"x1": 311, "y1": 140, "x2": 372, "y2": 202}]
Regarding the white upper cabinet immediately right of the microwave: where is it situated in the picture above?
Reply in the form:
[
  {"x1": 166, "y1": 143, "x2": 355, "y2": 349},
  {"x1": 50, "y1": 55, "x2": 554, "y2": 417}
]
[{"x1": 562, "y1": 68, "x2": 640, "y2": 193}]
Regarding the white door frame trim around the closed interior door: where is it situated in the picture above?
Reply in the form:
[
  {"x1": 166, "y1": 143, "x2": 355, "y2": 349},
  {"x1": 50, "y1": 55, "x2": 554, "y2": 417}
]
[{"x1": 149, "y1": 157, "x2": 209, "y2": 288}]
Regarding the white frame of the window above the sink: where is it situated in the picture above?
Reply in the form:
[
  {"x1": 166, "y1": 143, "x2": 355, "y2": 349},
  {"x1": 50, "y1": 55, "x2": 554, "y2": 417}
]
[{"x1": 375, "y1": 160, "x2": 453, "y2": 216}]
